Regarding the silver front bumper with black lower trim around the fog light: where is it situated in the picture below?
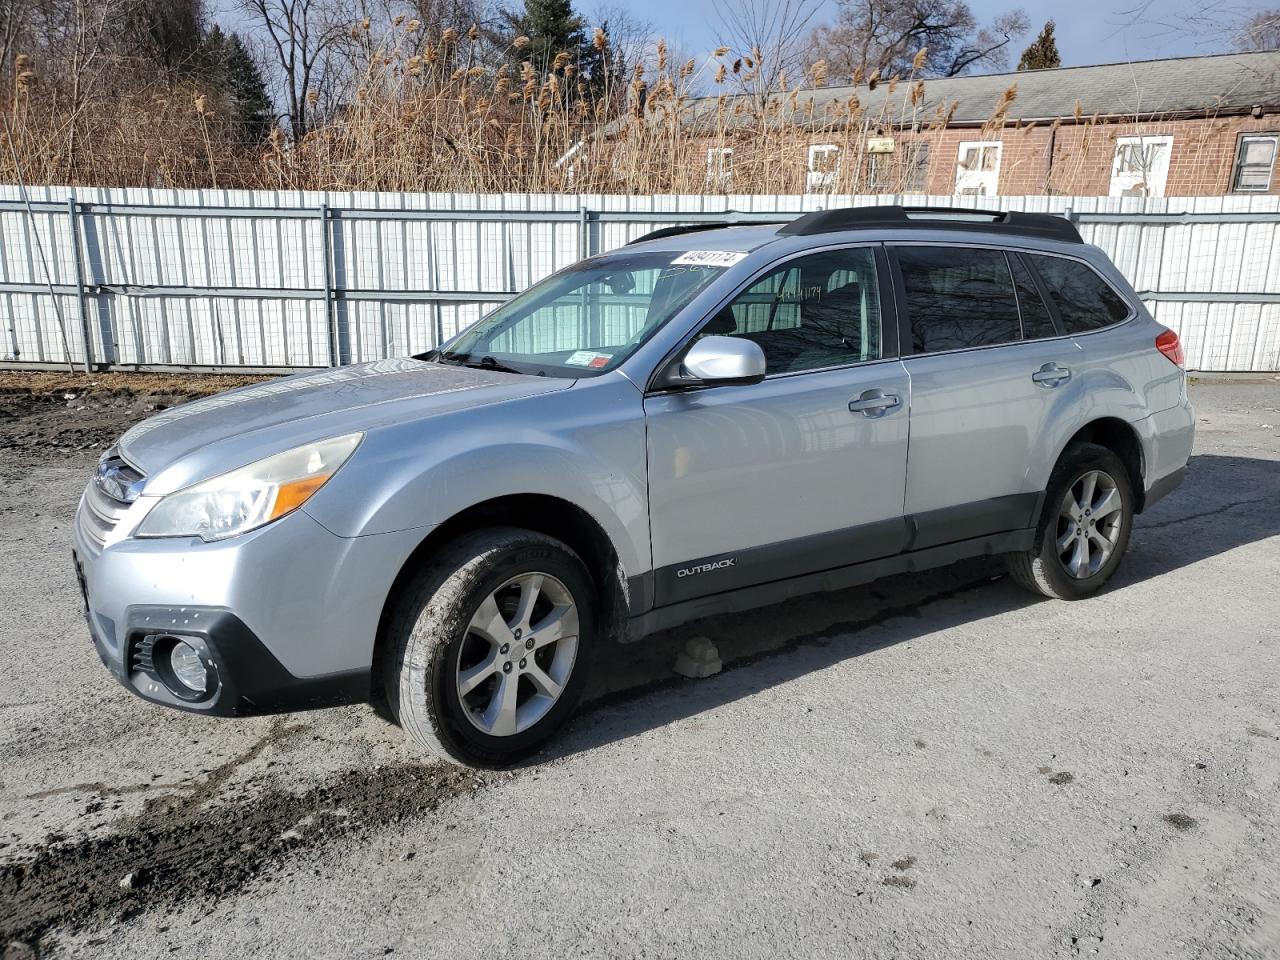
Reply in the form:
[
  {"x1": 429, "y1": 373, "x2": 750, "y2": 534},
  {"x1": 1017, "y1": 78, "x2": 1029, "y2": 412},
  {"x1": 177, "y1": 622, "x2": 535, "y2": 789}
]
[{"x1": 74, "y1": 503, "x2": 426, "y2": 716}]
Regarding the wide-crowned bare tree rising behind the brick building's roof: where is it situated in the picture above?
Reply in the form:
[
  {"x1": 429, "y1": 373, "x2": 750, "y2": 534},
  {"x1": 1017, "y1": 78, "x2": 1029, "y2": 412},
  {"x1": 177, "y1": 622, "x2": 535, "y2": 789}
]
[{"x1": 809, "y1": 0, "x2": 1030, "y2": 78}]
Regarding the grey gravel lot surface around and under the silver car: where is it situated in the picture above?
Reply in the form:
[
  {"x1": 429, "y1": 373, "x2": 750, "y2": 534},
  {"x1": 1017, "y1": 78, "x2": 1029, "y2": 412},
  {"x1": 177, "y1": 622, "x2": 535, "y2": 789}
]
[{"x1": 0, "y1": 381, "x2": 1280, "y2": 960}]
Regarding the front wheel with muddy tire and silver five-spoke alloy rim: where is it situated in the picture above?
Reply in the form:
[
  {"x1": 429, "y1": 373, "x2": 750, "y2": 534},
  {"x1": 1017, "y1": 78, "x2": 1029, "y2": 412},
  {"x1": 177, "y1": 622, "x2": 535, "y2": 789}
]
[{"x1": 381, "y1": 527, "x2": 596, "y2": 767}]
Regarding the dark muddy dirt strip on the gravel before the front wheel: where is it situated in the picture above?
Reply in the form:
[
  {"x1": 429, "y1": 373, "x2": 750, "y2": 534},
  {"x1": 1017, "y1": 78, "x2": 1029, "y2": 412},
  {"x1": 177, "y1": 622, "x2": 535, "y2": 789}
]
[{"x1": 0, "y1": 730, "x2": 492, "y2": 948}]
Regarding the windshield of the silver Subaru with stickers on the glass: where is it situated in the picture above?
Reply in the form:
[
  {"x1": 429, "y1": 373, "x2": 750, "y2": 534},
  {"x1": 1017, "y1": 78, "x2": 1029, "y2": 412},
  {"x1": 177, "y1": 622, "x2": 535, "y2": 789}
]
[{"x1": 428, "y1": 251, "x2": 724, "y2": 378}]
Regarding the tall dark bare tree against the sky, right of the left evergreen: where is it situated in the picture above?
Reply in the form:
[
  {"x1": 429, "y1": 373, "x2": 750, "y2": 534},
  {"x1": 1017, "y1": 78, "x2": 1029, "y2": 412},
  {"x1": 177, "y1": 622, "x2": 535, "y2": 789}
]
[{"x1": 241, "y1": 0, "x2": 351, "y2": 140}]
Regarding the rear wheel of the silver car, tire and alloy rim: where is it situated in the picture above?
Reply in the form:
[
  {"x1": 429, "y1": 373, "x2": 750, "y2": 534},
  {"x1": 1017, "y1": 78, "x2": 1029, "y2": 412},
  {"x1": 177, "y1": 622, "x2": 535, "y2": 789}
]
[{"x1": 1005, "y1": 443, "x2": 1134, "y2": 600}]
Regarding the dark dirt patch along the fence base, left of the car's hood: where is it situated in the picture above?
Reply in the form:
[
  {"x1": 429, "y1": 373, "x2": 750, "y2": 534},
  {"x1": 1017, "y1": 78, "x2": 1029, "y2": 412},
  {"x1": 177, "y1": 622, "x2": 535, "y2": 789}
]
[{"x1": 0, "y1": 371, "x2": 269, "y2": 460}]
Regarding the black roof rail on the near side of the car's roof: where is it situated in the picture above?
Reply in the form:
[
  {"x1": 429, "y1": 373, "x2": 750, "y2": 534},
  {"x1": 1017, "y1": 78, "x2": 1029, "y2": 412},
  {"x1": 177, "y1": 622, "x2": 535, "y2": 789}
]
[{"x1": 778, "y1": 205, "x2": 1084, "y2": 243}]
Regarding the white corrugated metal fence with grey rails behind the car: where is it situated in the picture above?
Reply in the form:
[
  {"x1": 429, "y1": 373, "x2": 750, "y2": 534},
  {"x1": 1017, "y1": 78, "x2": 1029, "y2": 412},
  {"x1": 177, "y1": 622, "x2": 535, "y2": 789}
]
[{"x1": 0, "y1": 186, "x2": 1280, "y2": 371}]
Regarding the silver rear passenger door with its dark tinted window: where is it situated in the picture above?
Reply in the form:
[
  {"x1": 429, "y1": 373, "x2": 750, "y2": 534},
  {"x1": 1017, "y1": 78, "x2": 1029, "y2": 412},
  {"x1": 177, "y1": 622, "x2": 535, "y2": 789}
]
[{"x1": 890, "y1": 243, "x2": 1076, "y2": 549}]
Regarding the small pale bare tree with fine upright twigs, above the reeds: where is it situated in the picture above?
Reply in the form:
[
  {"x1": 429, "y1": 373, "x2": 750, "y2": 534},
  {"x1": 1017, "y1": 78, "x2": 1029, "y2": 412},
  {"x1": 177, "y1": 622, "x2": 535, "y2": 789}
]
[{"x1": 714, "y1": 0, "x2": 820, "y2": 110}]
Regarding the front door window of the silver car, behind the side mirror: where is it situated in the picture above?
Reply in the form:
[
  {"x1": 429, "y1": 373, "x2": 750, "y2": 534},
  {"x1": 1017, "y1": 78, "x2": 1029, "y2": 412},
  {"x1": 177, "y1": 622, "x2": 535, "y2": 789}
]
[{"x1": 699, "y1": 247, "x2": 882, "y2": 374}]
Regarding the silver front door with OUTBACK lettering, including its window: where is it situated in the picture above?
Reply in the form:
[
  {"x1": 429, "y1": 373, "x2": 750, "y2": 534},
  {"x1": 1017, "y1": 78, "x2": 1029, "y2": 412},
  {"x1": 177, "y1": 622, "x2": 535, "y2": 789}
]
[{"x1": 644, "y1": 244, "x2": 910, "y2": 605}]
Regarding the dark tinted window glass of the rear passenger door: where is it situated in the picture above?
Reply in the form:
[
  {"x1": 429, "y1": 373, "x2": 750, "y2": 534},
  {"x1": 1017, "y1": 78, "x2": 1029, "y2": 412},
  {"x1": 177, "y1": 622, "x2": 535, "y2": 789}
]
[{"x1": 897, "y1": 247, "x2": 1021, "y2": 353}]
